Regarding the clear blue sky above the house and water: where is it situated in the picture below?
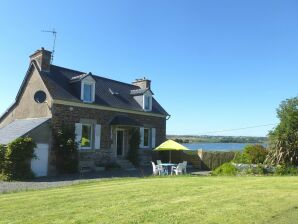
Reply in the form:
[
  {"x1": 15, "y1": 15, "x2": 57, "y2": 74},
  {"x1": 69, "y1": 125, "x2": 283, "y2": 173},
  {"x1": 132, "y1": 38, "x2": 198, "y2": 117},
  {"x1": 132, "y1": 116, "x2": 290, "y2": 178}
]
[{"x1": 0, "y1": 0, "x2": 298, "y2": 136}]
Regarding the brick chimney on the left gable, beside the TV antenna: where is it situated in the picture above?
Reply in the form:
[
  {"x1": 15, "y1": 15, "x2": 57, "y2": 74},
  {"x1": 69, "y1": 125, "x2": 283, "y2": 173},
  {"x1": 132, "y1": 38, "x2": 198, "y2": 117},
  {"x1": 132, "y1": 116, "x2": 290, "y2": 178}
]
[{"x1": 30, "y1": 47, "x2": 52, "y2": 72}]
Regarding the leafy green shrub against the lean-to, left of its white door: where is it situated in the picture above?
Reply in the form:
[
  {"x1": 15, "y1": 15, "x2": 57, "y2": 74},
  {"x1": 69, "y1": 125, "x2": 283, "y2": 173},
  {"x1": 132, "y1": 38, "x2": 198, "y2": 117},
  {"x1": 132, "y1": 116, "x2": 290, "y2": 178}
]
[{"x1": 1, "y1": 137, "x2": 36, "y2": 180}]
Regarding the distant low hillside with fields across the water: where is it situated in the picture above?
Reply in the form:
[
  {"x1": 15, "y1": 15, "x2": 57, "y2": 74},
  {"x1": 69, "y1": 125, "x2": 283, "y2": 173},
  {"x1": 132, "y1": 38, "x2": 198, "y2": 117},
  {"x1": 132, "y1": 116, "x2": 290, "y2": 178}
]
[{"x1": 167, "y1": 135, "x2": 268, "y2": 144}]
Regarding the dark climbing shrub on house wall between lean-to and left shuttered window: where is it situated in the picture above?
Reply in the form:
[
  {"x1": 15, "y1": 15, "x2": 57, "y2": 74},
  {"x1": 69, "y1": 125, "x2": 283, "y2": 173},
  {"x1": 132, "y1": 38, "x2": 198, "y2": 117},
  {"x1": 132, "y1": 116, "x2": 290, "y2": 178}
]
[{"x1": 54, "y1": 124, "x2": 79, "y2": 173}]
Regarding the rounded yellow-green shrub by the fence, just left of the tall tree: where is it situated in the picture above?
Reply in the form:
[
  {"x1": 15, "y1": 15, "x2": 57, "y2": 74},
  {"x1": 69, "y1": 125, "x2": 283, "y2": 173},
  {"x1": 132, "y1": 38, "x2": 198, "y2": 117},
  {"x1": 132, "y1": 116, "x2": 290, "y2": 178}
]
[{"x1": 234, "y1": 144, "x2": 268, "y2": 164}]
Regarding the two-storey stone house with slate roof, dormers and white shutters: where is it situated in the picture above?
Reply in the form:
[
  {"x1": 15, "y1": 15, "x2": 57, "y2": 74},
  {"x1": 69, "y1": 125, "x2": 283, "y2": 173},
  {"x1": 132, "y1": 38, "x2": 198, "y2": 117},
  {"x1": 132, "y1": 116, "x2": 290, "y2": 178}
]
[{"x1": 0, "y1": 48, "x2": 169, "y2": 176}]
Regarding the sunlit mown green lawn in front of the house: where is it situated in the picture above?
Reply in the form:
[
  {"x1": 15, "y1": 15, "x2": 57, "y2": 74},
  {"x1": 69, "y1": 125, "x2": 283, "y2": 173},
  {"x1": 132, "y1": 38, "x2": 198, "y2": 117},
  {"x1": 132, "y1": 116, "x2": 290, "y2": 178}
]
[{"x1": 0, "y1": 176, "x2": 298, "y2": 224}]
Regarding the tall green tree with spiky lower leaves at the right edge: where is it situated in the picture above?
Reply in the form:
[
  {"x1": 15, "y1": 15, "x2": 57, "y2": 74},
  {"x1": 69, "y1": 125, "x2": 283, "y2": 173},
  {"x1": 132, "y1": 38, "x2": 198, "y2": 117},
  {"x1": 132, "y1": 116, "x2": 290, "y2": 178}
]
[{"x1": 266, "y1": 97, "x2": 298, "y2": 166}]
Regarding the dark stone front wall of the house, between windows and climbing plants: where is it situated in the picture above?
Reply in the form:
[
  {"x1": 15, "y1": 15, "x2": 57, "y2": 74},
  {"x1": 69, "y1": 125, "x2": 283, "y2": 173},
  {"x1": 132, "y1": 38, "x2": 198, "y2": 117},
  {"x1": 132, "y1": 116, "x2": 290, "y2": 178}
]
[{"x1": 51, "y1": 104, "x2": 166, "y2": 172}]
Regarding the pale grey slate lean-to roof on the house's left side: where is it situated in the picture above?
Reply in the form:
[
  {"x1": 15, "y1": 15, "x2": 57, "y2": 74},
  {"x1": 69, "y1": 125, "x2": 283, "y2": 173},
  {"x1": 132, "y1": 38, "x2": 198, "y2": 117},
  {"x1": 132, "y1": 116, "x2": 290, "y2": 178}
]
[{"x1": 0, "y1": 117, "x2": 51, "y2": 145}]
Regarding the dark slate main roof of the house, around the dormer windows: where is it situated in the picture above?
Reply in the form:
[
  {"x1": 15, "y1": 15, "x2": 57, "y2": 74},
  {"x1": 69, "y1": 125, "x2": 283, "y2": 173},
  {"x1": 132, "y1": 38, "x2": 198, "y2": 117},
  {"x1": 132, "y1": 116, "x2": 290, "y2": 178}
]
[{"x1": 41, "y1": 65, "x2": 168, "y2": 115}]
